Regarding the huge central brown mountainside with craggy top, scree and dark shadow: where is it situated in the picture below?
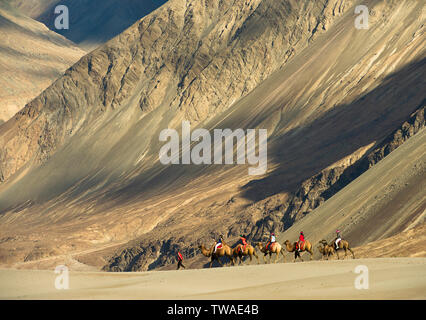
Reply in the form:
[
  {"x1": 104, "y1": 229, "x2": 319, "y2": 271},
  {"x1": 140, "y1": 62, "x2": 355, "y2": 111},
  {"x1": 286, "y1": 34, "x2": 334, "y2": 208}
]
[{"x1": 0, "y1": 0, "x2": 425, "y2": 271}]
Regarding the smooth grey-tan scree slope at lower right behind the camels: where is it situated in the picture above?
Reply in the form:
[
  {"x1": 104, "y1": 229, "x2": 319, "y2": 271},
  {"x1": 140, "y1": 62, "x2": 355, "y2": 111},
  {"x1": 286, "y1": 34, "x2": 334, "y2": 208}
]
[{"x1": 279, "y1": 125, "x2": 426, "y2": 257}]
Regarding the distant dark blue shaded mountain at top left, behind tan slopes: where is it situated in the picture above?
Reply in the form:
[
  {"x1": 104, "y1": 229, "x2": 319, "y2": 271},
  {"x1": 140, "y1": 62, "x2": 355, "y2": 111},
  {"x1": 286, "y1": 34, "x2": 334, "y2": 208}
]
[{"x1": 11, "y1": 0, "x2": 167, "y2": 50}]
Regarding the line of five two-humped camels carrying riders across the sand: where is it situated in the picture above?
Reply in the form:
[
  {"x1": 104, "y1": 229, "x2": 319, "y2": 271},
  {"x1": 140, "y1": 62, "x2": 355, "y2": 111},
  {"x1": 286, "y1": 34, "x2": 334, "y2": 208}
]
[{"x1": 199, "y1": 230, "x2": 355, "y2": 268}]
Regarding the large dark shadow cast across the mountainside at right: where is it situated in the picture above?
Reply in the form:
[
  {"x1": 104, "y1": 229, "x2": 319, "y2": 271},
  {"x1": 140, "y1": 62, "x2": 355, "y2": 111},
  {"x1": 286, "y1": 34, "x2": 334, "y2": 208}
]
[{"x1": 240, "y1": 59, "x2": 426, "y2": 201}]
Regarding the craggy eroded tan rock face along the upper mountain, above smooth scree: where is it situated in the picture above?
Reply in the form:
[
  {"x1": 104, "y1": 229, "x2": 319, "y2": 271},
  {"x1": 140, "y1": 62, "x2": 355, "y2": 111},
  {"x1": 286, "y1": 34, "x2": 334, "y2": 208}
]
[{"x1": 0, "y1": 0, "x2": 350, "y2": 184}]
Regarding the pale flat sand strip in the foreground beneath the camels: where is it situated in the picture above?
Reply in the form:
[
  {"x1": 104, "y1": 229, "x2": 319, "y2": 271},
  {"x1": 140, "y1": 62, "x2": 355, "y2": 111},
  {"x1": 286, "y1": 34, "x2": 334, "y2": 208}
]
[{"x1": 0, "y1": 258, "x2": 426, "y2": 299}]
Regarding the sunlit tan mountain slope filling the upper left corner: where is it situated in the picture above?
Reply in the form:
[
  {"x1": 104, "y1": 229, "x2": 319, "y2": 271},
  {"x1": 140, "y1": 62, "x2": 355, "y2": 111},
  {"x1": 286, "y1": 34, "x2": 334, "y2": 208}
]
[{"x1": 0, "y1": 0, "x2": 85, "y2": 123}]
